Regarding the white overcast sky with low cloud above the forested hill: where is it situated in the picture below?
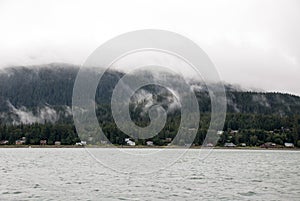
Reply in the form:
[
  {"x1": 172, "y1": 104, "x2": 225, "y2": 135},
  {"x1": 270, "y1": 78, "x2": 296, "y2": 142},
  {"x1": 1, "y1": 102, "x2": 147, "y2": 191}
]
[{"x1": 0, "y1": 0, "x2": 300, "y2": 95}]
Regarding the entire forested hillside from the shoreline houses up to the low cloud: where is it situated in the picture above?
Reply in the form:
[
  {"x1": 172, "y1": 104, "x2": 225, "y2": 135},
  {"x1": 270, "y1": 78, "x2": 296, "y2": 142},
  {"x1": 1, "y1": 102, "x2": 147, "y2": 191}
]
[{"x1": 0, "y1": 64, "x2": 300, "y2": 147}]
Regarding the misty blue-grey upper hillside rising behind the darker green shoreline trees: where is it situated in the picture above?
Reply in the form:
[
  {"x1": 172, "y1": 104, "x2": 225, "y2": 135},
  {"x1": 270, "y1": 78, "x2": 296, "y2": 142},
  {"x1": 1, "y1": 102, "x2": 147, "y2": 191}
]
[{"x1": 0, "y1": 63, "x2": 300, "y2": 123}]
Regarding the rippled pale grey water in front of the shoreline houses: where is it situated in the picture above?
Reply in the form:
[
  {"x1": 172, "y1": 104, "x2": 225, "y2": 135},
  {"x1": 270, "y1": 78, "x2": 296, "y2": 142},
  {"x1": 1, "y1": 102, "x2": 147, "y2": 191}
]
[{"x1": 0, "y1": 148, "x2": 300, "y2": 201}]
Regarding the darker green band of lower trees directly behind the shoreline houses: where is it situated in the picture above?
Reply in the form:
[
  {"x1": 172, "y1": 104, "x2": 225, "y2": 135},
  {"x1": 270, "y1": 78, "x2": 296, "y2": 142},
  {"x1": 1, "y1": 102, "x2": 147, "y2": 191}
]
[{"x1": 0, "y1": 111, "x2": 300, "y2": 147}]
